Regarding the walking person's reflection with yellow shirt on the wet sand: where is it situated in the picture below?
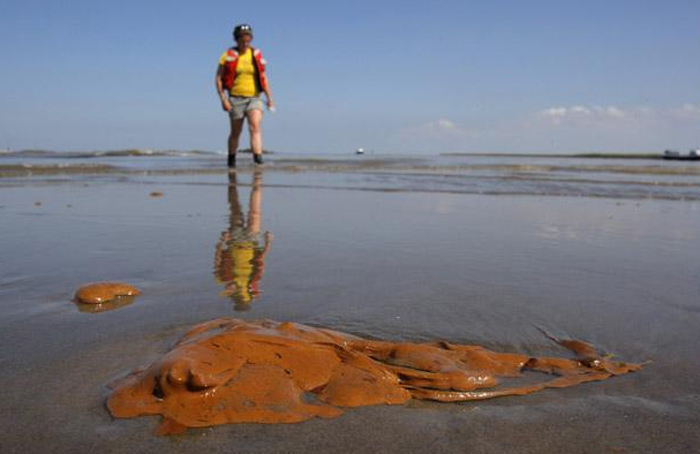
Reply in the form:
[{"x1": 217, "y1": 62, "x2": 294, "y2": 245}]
[{"x1": 214, "y1": 171, "x2": 272, "y2": 311}]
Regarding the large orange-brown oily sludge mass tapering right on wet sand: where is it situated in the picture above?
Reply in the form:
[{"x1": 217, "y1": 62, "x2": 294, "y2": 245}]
[{"x1": 107, "y1": 318, "x2": 641, "y2": 435}]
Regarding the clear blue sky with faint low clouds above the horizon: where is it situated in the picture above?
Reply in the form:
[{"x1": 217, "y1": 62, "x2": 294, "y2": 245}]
[{"x1": 0, "y1": 0, "x2": 700, "y2": 154}]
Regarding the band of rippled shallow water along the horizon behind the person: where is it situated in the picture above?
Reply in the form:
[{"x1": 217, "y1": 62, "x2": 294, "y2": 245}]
[{"x1": 0, "y1": 152, "x2": 700, "y2": 200}]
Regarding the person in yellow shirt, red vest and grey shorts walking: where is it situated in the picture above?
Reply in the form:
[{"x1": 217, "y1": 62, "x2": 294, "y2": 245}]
[{"x1": 216, "y1": 24, "x2": 274, "y2": 168}]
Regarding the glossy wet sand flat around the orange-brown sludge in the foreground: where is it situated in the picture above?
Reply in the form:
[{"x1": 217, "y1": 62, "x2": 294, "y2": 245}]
[{"x1": 0, "y1": 168, "x2": 700, "y2": 453}]
